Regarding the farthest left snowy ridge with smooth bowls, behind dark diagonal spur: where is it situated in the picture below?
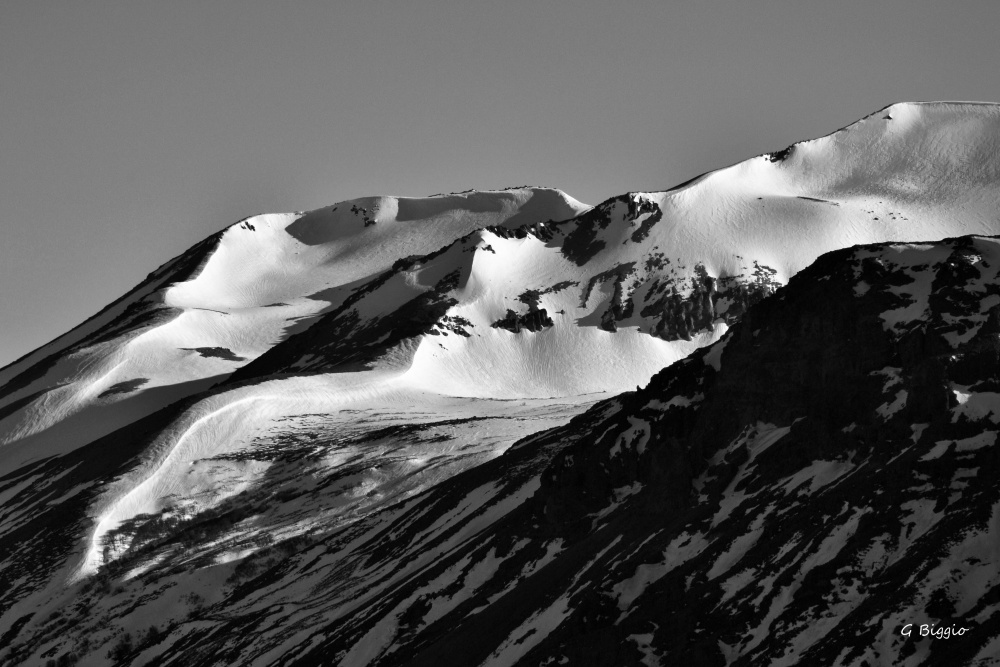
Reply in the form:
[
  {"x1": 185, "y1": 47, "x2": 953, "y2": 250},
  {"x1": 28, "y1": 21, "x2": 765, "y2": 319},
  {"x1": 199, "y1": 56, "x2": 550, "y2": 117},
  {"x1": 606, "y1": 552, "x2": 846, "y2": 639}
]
[{"x1": 0, "y1": 188, "x2": 587, "y2": 457}]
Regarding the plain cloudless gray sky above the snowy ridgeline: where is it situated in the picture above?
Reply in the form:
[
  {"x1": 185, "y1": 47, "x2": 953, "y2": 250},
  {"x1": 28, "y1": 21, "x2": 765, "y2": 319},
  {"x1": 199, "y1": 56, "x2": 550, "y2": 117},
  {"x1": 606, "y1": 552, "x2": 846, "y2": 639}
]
[{"x1": 0, "y1": 0, "x2": 1000, "y2": 366}]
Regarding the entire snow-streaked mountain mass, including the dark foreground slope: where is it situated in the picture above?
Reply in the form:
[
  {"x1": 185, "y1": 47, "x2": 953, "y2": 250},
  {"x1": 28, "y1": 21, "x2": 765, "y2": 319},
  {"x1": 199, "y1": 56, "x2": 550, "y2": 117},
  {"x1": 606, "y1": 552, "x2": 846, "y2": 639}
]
[{"x1": 0, "y1": 104, "x2": 1000, "y2": 665}]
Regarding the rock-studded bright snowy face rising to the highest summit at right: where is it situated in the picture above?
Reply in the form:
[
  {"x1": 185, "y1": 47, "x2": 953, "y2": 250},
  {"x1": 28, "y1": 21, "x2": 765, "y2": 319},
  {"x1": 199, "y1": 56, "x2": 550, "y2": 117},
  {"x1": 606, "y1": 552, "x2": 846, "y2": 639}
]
[{"x1": 229, "y1": 104, "x2": 1000, "y2": 396}]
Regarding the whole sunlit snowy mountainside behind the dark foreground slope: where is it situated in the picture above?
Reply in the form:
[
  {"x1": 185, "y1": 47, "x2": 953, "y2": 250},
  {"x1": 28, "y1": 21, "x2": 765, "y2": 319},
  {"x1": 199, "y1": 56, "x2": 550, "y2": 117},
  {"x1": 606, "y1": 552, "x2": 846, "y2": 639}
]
[{"x1": 0, "y1": 103, "x2": 1000, "y2": 664}]
